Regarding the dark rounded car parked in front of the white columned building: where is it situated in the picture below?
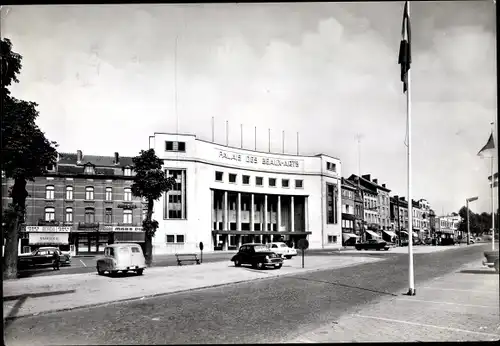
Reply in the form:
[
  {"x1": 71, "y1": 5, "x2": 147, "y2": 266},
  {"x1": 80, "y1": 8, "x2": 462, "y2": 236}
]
[{"x1": 231, "y1": 243, "x2": 283, "y2": 269}]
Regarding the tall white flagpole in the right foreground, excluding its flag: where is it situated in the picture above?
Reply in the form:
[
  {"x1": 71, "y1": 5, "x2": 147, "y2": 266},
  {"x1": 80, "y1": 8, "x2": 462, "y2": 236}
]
[{"x1": 406, "y1": 1, "x2": 416, "y2": 296}]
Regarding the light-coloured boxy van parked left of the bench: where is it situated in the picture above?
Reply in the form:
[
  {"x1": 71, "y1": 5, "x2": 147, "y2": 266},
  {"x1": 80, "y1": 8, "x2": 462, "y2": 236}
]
[{"x1": 96, "y1": 243, "x2": 146, "y2": 275}]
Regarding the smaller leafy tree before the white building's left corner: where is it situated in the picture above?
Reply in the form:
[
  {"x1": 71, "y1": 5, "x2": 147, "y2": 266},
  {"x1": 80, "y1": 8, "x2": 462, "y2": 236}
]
[{"x1": 132, "y1": 149, "x2": 175, "y2": 267}]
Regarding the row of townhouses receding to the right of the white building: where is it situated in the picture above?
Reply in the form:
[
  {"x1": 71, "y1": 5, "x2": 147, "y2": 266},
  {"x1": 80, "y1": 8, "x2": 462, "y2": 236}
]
[{"x1": 341, "y1": 174, "x2": 436, "y2": 245}]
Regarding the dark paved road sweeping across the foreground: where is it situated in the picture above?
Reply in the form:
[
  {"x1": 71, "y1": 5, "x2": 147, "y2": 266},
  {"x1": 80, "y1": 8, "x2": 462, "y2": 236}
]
[{"x1": 4, "y1": 245, "x2": 494, "y2": 345}]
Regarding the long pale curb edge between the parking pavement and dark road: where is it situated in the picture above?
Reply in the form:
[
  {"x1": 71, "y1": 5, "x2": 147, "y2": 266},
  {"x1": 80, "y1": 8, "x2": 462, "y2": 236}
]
[{"x1": 3, "y1": 259, "x2": 383, "y2": 321}]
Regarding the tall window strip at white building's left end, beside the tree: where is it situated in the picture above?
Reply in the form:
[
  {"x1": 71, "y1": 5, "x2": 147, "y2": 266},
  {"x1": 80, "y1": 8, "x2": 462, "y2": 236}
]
[{"x1": 164, "y1": 169, "x2": 187, "y2": 219}]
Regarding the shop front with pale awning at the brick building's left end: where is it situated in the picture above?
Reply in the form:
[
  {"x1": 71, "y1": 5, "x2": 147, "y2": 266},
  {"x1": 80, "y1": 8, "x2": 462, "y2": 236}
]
[{"x1": 21, "y1": 226, "x2": 71, "y2": 253}]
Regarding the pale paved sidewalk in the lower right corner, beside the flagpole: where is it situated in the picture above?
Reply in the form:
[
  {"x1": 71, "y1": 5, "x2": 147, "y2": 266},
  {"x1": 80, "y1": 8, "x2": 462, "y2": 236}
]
[{"x1": 289, "y1": 261, "x2": 500, "y2": 343}]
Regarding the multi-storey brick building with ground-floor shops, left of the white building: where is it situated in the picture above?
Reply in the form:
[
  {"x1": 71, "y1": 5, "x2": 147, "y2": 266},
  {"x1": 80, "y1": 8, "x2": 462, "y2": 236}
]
[{"x1": 2, "y1": 150, "x2": 145, "y2": 255}]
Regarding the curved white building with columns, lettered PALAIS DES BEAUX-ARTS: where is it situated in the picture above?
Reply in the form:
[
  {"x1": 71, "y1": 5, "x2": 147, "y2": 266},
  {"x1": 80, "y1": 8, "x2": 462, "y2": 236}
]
[{"x1": 149, "y1": 133, "x2": 342, "y2": 253}]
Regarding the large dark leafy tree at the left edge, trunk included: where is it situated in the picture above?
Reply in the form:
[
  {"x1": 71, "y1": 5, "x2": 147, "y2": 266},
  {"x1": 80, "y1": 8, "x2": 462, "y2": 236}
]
[{"x1": 0, "y1": 39, "x2": 57, "y2": 279}]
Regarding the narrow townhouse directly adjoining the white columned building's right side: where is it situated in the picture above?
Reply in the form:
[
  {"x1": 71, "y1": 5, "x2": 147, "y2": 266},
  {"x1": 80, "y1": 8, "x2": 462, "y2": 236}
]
[{"x1": 341, "y1": 178, "x2": 358, "y2": 246}]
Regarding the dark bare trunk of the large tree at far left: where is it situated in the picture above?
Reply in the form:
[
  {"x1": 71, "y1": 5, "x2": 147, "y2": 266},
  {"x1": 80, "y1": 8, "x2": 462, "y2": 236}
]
[{"x1": 3, "y1": 178, "x2": 28, "y2": 279}]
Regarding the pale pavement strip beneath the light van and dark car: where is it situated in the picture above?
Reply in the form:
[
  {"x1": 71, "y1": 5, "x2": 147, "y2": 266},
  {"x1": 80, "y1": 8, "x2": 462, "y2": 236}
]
[{"x1": 3, "y1": 256, "x2": 381, "y2": 318}]
